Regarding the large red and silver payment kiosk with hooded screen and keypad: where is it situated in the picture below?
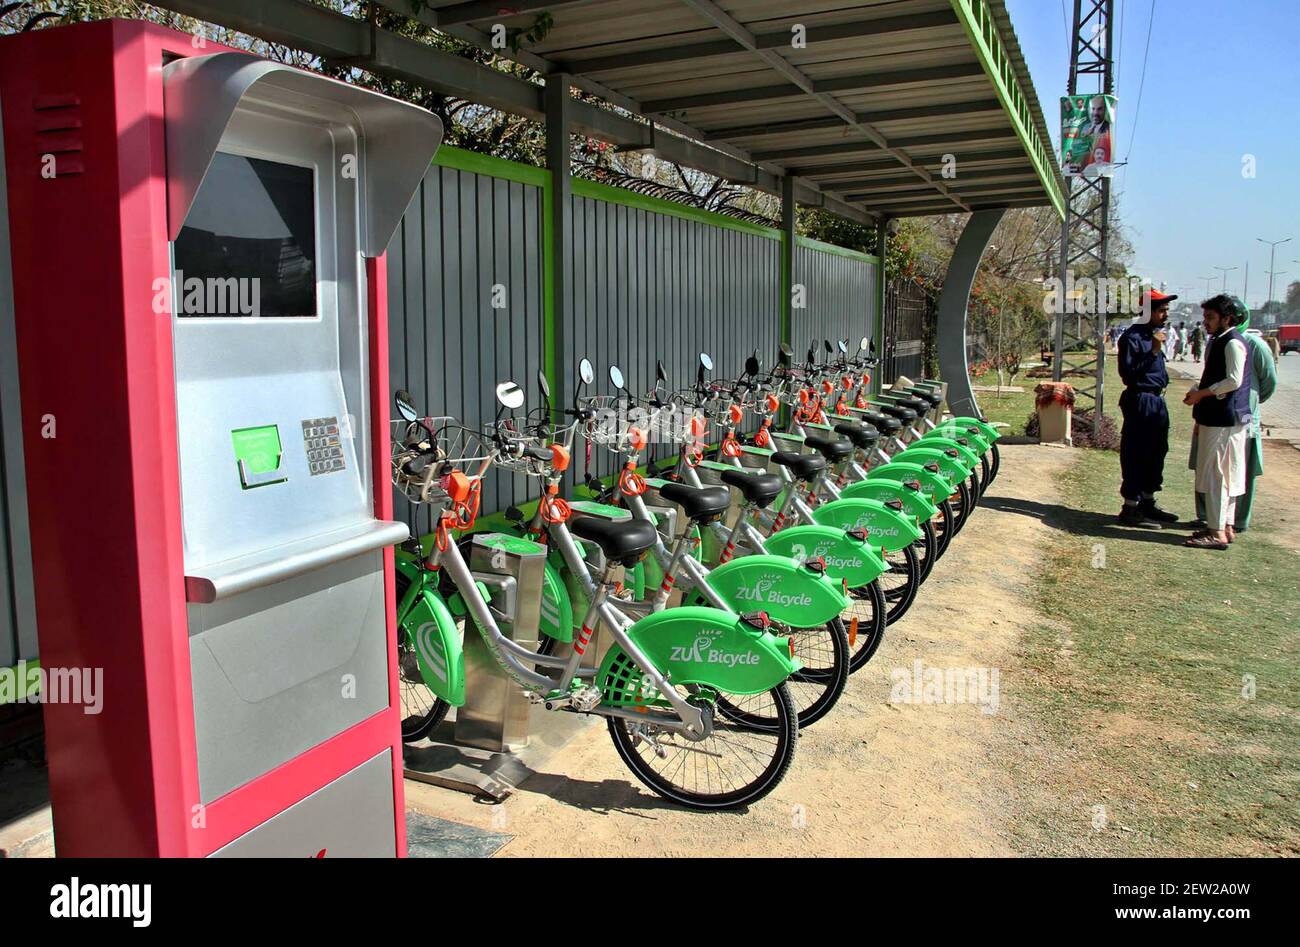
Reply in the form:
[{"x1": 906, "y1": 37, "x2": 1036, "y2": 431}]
[{"x1": 0, "y1": 21, "x2": 442, "y2": 857}]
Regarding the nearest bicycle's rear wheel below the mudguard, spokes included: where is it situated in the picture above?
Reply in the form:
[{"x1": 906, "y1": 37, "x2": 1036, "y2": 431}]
[{"x1": 608, "y1": 683, "x2": 800, "y2": 810}]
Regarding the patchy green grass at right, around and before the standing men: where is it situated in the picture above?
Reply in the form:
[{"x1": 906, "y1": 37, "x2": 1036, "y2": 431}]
[{"x1": 1015, "y1": 359, "x2": 1300, "y2": 855}]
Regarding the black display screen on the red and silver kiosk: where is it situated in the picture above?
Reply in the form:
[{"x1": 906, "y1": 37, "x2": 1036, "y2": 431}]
[{"x1": 173, "y1": 151, "x2": 317, "y2": 319}]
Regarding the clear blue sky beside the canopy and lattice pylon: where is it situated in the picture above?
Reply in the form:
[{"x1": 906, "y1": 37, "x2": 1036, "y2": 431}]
[{"x1": 1006, "y1": 0, "x2": 1300, "y2": 306}]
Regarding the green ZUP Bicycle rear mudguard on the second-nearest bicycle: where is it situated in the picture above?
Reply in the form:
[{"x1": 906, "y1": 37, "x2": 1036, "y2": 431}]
[{"x1": 707, "y1": 555, "x2": 849, "y2": 628}]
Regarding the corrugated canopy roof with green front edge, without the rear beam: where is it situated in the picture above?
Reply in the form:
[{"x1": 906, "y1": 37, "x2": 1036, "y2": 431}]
[{"x1": 416, "y1": 0, "x2": 1063, "y2": 217}]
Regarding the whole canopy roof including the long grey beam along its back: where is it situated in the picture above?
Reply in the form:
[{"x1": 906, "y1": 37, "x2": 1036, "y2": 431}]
[{"x1": 153, "y1": 0, "x2": 1065, "y2": 220}]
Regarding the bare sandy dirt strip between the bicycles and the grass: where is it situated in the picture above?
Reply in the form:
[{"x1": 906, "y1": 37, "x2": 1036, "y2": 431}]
[{"x1": 407, "y1": 445, "x2": 1075, "y2": 856}]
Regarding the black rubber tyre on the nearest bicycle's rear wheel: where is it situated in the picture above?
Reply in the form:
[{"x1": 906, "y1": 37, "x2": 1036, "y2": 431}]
[{"x1": 608, "y1": 683, "x2": 800, "y2": 810}]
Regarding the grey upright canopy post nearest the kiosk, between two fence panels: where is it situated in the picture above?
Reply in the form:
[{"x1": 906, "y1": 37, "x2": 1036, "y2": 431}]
[{"x1": 542, "y1": 73, "x2": 577, "y2": 411}]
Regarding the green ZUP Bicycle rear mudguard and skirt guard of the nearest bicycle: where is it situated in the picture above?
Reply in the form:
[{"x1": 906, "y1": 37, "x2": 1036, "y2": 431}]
[{"x1": 595, "y1": 606, "x2": 800, "y2": 708}]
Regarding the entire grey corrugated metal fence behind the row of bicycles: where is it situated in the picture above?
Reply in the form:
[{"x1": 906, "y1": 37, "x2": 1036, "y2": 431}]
[{"x1": 389, "y1": 148, "x2": 878, "y2": 532}]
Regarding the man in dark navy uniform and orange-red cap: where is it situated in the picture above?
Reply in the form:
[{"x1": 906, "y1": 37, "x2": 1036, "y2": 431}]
[{"x1": 1119, "y1": 290, "x2": 1178, "y2": 529}]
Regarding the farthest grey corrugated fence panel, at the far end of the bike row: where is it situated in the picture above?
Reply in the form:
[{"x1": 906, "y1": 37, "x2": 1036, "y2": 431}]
[{"x1": 790, "y1": 241, "x2": 880, "y2": 359}]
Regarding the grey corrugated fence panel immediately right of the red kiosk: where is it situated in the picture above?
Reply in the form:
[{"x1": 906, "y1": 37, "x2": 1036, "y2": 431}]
[{"x1": 389, "y1": 167, "x2": 542, "y2": 532}]
